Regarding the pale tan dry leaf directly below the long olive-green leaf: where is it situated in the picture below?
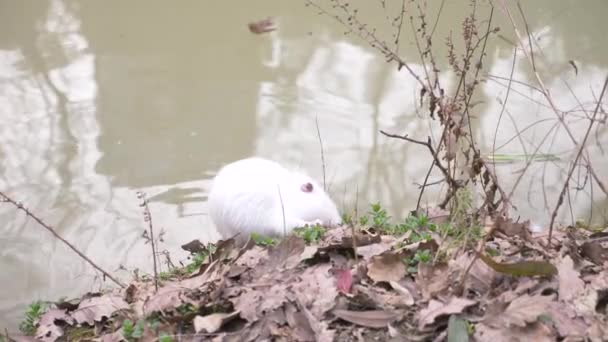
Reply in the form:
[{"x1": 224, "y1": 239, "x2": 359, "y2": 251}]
[{"x1": 483, "y1": 294, "x2": 553, "y2": 328}]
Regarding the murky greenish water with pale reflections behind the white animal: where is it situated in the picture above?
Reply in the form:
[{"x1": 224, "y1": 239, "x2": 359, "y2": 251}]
[{"x1": 0, "y1": 0, "x2": 608, "y2": 329}]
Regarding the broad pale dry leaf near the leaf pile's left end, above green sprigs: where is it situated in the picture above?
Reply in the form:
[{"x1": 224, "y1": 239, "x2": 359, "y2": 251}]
[{"x1": 71, "y1": 294, "x2": 129, "y2": 325}]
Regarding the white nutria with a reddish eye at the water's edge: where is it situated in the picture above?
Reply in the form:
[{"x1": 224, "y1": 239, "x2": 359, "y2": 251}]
[{"x1": 208, "y1": 157, "x2": 341, "y2": 242}]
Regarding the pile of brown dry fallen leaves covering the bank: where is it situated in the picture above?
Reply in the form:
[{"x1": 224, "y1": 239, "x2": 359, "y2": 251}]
[{"x1": 16, "y1": 220, "x2": 608, "y2": 342}]
